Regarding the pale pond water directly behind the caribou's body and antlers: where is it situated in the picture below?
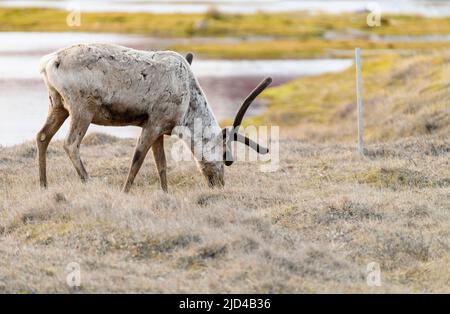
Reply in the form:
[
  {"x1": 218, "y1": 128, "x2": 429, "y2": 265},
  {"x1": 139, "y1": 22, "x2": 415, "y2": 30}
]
[{"x1": 0, "y1": 32, "x2": 352, "y2": 146}]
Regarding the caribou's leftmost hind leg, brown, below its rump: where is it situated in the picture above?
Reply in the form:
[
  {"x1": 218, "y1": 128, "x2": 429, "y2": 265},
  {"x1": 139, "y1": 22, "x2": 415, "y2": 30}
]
[{"x1": 36, "y1": 88, "x2": 69, "y2": 188}]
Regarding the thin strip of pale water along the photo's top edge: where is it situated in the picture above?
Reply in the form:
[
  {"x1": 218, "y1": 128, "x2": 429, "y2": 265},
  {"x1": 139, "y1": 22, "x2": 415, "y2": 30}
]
[{"x1": 0, "y1": 0, "x2": 450, "y2": 16}]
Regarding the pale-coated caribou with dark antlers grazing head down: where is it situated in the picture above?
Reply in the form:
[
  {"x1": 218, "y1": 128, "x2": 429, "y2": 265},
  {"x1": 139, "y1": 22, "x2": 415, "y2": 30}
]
[{"x1": 36, "y1": 44, "x2": 272, "y2": 192}]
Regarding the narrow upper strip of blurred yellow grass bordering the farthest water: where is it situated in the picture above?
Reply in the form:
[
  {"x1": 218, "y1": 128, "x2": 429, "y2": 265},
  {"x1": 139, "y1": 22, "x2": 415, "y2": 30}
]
[{"x1": 0, "y1": 8, "x2": 450, "y2": 39}]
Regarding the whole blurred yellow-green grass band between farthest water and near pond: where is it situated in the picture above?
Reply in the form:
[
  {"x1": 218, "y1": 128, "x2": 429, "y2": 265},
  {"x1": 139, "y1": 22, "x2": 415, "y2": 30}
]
[{"x1": 0, "y1": 8, "x2": 450, "y2": 59}]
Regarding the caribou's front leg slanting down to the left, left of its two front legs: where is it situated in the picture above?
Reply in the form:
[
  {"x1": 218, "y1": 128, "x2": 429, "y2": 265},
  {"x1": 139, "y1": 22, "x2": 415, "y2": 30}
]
[{"x1": 122, "y1": 126, "x2": 159, "y2": 193}]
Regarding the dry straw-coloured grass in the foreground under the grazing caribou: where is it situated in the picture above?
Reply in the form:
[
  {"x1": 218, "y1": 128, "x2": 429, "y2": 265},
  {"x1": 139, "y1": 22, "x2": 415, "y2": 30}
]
[{"x1": 0, "y1": 135, "x2": 450, "y2": 293}]
